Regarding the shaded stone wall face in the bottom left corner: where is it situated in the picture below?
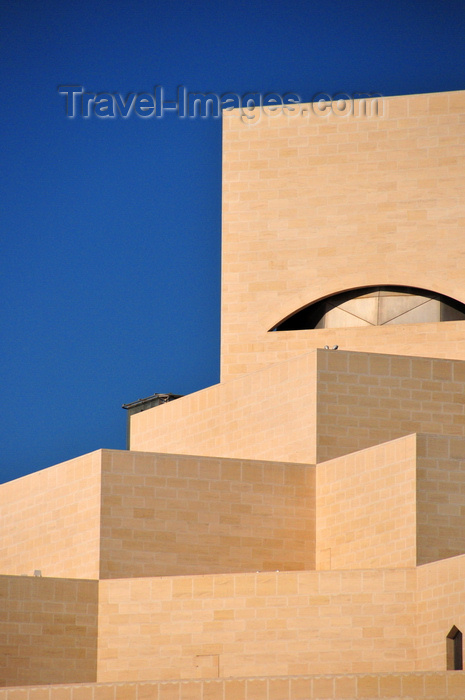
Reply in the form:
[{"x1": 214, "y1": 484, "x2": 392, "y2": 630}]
[{"x1": 0, "y1": 576, "x2": 98, "y2": 686}]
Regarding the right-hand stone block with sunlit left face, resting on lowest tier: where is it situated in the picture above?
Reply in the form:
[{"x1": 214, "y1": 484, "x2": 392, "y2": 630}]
[{"x1": 316, "y1": 434, "x2": 465, "y2": 569}]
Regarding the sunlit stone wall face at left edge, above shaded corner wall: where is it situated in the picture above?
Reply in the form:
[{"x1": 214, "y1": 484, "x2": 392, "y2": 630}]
[{"x1": 0, "y1": 452, "x2": 100, "y2": 578}]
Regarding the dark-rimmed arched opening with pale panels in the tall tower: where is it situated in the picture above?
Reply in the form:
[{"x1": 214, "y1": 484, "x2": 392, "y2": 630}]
[{"x1": 270, "y1": 285, "x2": 465, "y2": 331}]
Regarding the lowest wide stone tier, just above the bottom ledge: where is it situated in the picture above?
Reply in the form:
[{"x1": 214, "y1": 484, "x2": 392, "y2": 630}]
[{"x1": 0, "y1": 555, "x2": 465, "y2": 697}]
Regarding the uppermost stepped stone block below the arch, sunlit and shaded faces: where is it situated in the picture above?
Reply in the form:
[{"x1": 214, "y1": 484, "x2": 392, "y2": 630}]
[{"x1": 131, "y1": 349, "x2": 465, "y2": 464}]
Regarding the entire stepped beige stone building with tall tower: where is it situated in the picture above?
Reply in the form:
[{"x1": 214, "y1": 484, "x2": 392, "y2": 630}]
[{"x1": 0, "y1": 92, "x2": 465, "y2": 700}]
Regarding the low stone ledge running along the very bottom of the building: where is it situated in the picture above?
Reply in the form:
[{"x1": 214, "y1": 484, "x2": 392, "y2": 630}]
[{"x1": 0, "y1": 671, "x2": 465, "y2": 700}]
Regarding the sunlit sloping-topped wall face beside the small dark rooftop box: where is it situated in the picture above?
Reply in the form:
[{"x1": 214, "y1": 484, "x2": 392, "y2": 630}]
[{"x1": 131, "y1": 352, "x2": 316, "y2": 464}]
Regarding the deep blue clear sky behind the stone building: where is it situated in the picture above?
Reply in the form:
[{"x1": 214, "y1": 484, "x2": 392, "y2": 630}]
[{"x1": 0, "y1": 0, "x2": 465, "y2": 482}]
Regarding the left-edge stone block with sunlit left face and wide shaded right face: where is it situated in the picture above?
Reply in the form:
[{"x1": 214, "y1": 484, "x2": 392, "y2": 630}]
[{"x1": 0, "y1": 450, "x2": 315, "y2": 579}]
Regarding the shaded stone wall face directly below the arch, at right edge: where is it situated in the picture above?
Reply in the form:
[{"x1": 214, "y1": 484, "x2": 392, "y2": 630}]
[{"x1": 317, "y1": 350, "x2": 465, "y2": 462}]
